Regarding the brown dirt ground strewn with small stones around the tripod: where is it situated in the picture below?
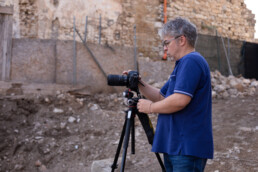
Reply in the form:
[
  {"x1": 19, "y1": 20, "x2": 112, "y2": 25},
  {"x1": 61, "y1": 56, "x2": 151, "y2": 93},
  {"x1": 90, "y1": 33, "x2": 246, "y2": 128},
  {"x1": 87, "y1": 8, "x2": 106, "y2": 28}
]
[{"x1": 0, "y1": 85, "x2": 258, "y2": 172}]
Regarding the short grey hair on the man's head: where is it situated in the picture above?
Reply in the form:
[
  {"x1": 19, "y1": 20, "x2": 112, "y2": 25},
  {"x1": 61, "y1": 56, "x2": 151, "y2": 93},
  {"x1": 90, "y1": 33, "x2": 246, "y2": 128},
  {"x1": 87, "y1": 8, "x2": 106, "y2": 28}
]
[{"x1": 161, "y1": 17, "x2": 197, "y2": 47}]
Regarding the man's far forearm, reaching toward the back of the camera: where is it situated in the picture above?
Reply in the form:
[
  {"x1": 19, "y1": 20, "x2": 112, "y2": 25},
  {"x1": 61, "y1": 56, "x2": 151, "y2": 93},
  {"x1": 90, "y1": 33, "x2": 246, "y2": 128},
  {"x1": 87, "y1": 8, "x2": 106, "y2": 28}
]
[{"x1": 138, "y1": 81, "x2": 164, "y2": 102}]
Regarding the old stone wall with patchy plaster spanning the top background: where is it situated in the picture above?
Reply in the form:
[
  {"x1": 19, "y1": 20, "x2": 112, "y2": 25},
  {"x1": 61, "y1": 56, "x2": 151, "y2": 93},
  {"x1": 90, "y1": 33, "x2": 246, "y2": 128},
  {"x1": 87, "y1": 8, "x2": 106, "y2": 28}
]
[{"x1": 0, "y1": 0, "x2": 255, "y2": 59}]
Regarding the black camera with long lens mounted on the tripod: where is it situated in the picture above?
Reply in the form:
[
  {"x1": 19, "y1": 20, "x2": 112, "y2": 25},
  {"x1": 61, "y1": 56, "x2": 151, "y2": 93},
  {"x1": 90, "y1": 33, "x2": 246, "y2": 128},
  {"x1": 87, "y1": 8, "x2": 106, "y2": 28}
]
[{"x1": 107, "y1": 71, "x2": 139, "y2": 91}]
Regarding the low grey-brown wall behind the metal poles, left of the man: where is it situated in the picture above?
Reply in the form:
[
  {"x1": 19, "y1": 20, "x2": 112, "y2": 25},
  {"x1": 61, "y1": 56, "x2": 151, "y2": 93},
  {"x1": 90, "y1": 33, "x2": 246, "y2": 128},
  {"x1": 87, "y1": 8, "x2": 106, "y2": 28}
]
[{"x1": 10, "y1": 38, "x2": 174, "y2": 93}]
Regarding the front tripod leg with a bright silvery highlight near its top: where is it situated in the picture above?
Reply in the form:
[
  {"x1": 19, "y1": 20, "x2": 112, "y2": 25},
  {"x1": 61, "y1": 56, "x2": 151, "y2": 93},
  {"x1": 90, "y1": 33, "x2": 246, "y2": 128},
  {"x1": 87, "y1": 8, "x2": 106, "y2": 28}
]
[{"x1": 120, "y1": 110, "x2": 132, "y2": 172}]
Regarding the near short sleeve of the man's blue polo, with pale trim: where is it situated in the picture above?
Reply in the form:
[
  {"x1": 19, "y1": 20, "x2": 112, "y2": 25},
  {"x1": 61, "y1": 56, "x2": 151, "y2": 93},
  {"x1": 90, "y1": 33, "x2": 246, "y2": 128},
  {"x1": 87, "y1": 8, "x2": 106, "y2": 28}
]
[{"x1": 174, "y1": 58, "x2": 202, "y2": 97}]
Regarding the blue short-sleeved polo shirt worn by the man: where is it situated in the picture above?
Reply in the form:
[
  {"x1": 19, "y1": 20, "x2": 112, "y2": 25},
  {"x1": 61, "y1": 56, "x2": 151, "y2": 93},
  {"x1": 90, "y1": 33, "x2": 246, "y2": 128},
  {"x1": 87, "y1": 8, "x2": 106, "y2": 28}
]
[{"x1": 152, "y1": 52, "x2": 213, "y2": 159}]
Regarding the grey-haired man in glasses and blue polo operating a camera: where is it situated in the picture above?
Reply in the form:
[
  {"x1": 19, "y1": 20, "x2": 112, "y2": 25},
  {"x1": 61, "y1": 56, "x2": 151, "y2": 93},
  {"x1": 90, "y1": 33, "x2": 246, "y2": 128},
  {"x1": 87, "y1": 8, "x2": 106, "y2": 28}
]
[{"x1": 124, "y1": 18, "x2": 213, "y2": 172}]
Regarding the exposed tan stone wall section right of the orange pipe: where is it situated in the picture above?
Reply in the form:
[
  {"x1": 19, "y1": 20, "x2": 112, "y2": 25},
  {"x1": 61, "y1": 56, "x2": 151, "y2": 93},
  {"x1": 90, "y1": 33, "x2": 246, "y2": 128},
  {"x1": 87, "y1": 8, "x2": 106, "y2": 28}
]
[{"x1": 168, "y1": 0, "x2": 255, "y2": 41}]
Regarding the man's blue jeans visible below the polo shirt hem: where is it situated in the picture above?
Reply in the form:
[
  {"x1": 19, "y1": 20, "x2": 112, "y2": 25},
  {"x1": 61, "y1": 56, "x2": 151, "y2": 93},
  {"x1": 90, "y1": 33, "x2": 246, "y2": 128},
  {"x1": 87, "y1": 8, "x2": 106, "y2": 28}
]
[{"x1": 164, "y1": 153, "x2": 207, "y2": 172}]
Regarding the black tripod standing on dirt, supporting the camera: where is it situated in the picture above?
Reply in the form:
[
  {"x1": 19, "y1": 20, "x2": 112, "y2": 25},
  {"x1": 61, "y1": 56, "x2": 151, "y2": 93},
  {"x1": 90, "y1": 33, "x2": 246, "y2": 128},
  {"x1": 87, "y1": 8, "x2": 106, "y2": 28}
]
[{"x1": 111, "y1": 89, "x2": 166, "y2": 172}]
